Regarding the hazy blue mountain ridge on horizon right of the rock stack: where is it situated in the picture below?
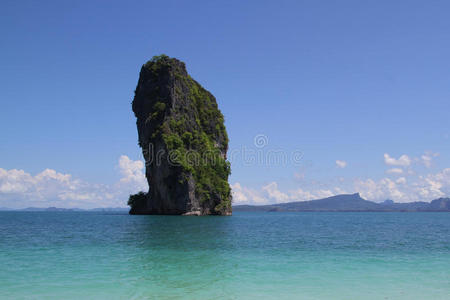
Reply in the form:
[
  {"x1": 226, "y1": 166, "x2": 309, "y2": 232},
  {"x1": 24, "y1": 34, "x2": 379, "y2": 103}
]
[{"x1": 233, "y1": 193, "x2": 450, "y2": 212}]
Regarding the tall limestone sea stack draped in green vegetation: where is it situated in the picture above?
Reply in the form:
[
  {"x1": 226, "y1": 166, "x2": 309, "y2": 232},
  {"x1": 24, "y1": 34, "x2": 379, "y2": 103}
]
[{"x1": 129, "y1": 55, "x2": 231, "y2": 215}]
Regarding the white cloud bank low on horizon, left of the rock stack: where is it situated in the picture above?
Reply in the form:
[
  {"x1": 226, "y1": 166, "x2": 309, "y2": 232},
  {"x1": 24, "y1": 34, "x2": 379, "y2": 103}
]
[{"x1": 0, "y1": 155, "x2": 148, "y2": 208}]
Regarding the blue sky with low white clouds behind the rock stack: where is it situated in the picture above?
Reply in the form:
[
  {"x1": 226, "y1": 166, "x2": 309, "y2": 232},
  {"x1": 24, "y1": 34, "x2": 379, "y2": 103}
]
[{"x1": 0, "y1": 1, "x2": 450, "y2": 207}]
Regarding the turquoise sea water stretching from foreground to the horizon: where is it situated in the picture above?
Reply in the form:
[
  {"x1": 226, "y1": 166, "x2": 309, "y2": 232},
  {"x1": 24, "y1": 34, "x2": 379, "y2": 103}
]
[{"x1": 0, "y1": 212, "x2": 450, "y2": 300}]
